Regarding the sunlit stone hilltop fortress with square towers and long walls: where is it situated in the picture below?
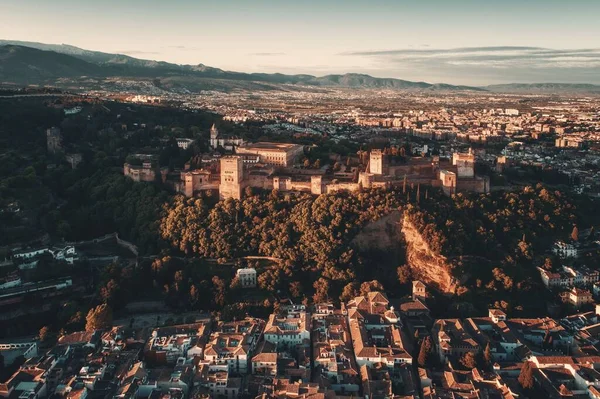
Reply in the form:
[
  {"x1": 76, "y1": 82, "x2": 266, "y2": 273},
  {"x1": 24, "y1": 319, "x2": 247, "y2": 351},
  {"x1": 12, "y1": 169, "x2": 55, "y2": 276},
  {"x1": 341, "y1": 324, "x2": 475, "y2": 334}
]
[{"x1": 124, "y1": 142, "x2": 490, "y2": 200}]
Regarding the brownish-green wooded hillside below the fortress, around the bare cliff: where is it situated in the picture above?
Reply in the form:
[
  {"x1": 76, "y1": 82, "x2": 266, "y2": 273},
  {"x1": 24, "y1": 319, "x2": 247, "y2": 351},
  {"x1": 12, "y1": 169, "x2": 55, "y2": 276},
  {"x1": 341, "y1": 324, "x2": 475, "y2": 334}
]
[{"x1": 160, "y1": 185, "x2": 598, "y2": 318}]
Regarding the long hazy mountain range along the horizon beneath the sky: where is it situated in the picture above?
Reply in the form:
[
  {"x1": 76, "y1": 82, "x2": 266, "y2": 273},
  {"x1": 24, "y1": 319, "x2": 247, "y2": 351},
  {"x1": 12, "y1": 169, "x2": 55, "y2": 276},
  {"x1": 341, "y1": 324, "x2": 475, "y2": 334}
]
[{"x1": 0, "y1": 40, "x2": 600, "y2": 92}]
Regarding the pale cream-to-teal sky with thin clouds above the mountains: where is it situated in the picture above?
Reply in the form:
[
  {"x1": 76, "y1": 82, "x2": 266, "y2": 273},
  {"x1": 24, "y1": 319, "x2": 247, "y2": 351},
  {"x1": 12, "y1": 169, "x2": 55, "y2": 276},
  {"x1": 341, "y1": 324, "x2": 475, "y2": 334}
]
[{"x1": 0, "y1": 0, "x2": 600, "y2": 85}]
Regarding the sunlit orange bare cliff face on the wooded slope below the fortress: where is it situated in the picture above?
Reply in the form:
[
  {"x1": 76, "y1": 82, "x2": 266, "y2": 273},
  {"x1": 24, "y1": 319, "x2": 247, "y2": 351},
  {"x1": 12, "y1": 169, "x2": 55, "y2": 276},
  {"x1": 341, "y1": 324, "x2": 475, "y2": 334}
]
[{"x1": 401, "y1": 214, "x2": 457, "y2": 294}]
